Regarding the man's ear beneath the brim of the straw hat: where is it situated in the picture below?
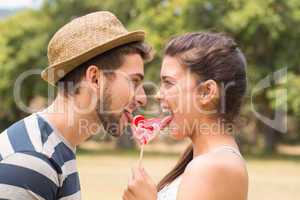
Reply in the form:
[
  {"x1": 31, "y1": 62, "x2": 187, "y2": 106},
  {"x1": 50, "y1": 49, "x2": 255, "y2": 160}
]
[{"x1": 85, "y1": 65, "x2": 103, "y2": 90}]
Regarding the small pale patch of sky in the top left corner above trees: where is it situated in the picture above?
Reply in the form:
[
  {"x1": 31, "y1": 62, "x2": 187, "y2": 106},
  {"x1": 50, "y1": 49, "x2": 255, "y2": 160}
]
[{"x1": 0, "y1": 0, "x2": 43, "y2": 10}]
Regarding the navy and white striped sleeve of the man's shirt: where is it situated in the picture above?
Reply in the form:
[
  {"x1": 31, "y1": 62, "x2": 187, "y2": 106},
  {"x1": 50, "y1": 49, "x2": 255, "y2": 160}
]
[{"x1": 0, "y1": 152, "x2": 59, "y2": 200}]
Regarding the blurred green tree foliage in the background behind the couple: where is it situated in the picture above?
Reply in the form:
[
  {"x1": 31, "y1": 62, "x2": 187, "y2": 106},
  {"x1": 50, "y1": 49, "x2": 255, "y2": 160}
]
[{"x1": 0, "y1": 0, "x2": 300, "y2": 152}]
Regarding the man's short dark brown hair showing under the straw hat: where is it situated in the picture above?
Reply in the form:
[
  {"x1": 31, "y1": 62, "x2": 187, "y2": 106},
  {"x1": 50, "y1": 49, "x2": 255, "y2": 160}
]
[{"x1": 57, "y1": 42, "x2": 153, "y2": 94}]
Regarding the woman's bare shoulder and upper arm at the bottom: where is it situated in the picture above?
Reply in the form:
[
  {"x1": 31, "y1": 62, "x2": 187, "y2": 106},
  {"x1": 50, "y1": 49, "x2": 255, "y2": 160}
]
[{"x1": 179, "y1": 152, "x2": 248, "y2": 200}]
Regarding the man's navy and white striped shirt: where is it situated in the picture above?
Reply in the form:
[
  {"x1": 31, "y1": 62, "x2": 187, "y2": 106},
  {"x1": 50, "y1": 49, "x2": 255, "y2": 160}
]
[{"x1": 0, "y1": 114, "x2": 81, "y2": 200}]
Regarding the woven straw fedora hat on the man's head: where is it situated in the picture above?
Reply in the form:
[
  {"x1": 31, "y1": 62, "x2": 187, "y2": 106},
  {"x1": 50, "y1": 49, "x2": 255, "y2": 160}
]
[{"x1": 41, "y1": 11, "x2": 145, "y2": 85}]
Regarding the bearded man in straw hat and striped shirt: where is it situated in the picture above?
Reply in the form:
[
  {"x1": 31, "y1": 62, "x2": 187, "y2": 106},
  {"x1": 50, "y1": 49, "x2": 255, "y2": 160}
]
[{"x1": 0, "y1": 12, "x2": 151, "y2": 200}]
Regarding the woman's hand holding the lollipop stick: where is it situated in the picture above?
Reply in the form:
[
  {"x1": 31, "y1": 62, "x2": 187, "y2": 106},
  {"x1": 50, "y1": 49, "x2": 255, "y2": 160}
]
[{"x1": 123, "y1": 167, "x2": 157, "y2": 200}]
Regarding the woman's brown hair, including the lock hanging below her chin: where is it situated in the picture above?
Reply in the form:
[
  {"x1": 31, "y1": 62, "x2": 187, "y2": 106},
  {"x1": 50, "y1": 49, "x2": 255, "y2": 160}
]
[{"x1": 157, "y1": 32, "x2": 247, "y2": 190}]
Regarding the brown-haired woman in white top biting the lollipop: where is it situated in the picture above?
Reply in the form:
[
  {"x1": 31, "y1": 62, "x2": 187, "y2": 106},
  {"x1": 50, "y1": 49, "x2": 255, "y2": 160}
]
[{"x1": 123, "y1": 33, "x2": 248, "y2": 200}]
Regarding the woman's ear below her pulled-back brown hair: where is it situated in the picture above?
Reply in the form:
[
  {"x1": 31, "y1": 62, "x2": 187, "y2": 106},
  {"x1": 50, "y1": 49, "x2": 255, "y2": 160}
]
[{"x1": 197, "y1": 79, "x2": 220, "y2": 107}]
